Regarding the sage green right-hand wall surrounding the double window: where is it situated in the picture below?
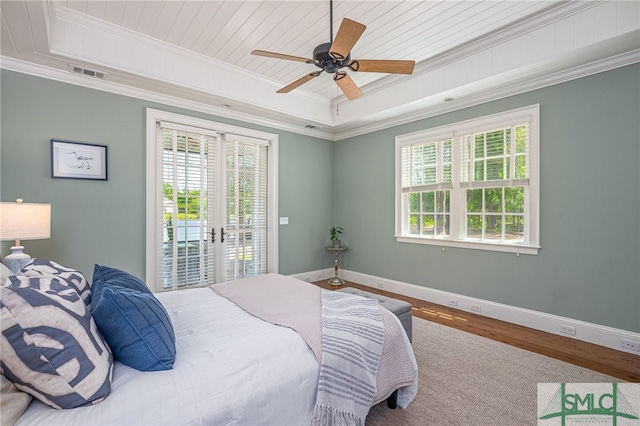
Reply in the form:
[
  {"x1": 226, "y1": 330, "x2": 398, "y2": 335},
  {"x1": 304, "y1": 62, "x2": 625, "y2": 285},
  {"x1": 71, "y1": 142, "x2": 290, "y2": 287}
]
[{"x1": 334, "y1": 65, "x2": 640, "y2": 332}]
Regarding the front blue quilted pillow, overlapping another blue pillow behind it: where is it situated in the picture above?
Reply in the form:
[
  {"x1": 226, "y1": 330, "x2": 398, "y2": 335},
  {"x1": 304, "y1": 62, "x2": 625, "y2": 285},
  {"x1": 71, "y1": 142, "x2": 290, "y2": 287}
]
[{"x1": 91, "y1": 280, "x2": 176, "y2": 371}]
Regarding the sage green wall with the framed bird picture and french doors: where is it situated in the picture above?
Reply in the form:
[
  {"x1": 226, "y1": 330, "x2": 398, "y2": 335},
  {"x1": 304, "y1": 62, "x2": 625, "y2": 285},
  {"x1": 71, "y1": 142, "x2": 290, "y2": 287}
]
[{"x1": 0, "y1": 70, "x2": 334, "y2": 278}]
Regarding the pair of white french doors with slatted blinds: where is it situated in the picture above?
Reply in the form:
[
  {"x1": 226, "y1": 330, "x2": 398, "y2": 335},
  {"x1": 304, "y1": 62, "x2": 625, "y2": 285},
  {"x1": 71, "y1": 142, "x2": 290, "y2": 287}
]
[{"x1": 147, "y1": 109, "x2": 275, "y2": 291}]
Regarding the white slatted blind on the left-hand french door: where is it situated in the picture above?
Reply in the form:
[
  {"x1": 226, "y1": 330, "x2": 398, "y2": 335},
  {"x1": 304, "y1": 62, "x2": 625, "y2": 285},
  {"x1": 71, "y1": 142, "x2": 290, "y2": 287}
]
[{"x1": 156, "y1": 122, "x2": 219, "y2": 290}]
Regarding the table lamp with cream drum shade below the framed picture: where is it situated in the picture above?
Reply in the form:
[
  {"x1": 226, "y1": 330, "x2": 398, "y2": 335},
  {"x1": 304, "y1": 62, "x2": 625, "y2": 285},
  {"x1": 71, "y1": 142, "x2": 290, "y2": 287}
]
[{"x1": 0, "y1": 198, "x2": 51, "y2": 274}]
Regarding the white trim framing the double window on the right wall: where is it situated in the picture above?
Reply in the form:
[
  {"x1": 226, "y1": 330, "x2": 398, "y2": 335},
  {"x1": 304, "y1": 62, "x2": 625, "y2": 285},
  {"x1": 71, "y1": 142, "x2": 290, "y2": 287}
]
[{"x1": 395, "y1": 104, "x2": 541, "y2": 255}]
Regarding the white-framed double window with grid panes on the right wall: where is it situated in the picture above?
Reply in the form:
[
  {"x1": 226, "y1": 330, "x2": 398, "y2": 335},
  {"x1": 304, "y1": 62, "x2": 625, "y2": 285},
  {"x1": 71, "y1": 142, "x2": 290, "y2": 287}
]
[{"x1": 396, "y1": 105, "x2": 539, "y2": 254}]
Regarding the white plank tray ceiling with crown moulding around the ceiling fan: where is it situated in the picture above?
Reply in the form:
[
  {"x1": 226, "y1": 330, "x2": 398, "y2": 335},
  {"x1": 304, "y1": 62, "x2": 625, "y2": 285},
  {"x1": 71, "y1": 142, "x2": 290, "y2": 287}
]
[{"x1": 0, "y1": 0, "x2": 640, "y2": 139}]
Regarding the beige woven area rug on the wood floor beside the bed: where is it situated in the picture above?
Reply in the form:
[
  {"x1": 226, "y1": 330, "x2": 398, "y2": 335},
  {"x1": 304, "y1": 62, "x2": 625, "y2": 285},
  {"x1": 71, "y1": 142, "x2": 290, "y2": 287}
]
[{"x1": 366, "y1": 317, "x2": 620, "y2": 426}]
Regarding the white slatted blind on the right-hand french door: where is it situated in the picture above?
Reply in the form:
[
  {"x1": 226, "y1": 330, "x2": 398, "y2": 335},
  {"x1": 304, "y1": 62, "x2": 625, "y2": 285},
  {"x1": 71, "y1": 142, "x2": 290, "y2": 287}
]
[{"x1": 225, "y1": 134, "x2": 269, "y2": 280}]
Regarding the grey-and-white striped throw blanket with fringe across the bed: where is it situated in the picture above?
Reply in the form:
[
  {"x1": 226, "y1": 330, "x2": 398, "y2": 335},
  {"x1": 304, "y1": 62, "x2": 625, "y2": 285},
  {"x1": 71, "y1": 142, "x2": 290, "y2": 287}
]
[{"x1": 311, "y1": 290, "x2": 384, "y2": 426}]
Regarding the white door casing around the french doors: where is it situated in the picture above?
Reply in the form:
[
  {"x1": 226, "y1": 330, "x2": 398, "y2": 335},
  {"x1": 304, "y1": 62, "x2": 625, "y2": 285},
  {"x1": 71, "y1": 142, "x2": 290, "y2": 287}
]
[{"x1": 145, "y1": 108, "x2": 279, "y2": 291}]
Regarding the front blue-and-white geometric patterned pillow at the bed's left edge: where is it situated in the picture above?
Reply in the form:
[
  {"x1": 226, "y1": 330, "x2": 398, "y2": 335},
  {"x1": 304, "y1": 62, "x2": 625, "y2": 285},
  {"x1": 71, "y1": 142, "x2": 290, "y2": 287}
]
[{"x1": 0, "y1": 276, "x2": 113, "y2": 408}]
